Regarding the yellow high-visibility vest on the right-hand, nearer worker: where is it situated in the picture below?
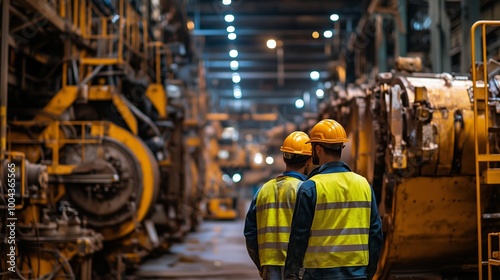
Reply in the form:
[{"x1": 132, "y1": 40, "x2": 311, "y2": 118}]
[{"x1": 304, "y1": 172, "x2": 372, "y2": 268}]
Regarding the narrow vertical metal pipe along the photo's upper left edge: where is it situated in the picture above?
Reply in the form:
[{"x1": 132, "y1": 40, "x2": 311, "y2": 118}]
[{"x1": 0, "y1": 0, "x2": 10, "y2": 159}]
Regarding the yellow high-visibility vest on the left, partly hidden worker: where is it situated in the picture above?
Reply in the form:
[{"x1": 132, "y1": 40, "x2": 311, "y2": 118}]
[{"x1": 255, "y1": 176, "x2": 302, "y2": 266}]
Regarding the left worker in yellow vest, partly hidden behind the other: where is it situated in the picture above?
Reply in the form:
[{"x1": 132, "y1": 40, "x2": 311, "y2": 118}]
[{"x1": 244, "y1": 131, "x2": 312, "y2": 280}]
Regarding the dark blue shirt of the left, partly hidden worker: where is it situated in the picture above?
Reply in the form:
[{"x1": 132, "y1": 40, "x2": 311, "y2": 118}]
[{"x1": 243, "y1": 171, "x2": 307, "y2": 271}]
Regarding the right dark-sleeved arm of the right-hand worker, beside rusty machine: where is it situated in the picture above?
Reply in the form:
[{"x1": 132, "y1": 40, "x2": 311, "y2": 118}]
[{"x1": 366, "y1": 185, "x2": 384, "y2": 279}]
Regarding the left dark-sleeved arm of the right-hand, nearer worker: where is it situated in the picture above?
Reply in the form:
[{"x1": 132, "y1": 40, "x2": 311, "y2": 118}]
[{"x1": 284, "y1": 181, "x2": 316, "y2": 279}]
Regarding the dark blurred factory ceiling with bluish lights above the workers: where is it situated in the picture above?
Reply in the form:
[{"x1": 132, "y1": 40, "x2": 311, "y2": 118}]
[{"x1": 186, "y1": 0, "x2": 369, "y2": 128}]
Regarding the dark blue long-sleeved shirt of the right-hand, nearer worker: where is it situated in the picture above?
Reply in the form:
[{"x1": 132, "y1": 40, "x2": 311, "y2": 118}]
[{"x1": 284, "y1": 161, "x2": 383, "y2": 279}]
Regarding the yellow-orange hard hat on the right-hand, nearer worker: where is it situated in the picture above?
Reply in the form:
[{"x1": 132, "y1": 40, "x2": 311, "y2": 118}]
[{"x1": 308, "y1": 119, "x2": 349, "y2": 144}]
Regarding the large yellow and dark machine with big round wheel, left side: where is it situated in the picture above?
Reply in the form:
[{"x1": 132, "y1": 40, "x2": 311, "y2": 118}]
[{"x1": 0, "y1": 0, "x2": 206, "y2": 279}]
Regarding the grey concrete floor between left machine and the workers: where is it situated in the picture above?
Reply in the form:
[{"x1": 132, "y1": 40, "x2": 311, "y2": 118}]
[{"x1": 135, "y1": 220, "x2": 260, "y2": 280}]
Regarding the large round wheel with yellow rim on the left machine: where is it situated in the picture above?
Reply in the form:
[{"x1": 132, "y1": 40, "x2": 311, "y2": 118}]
[{"x1": 62, "y1": 123, "x2": 159, "y2": 240}]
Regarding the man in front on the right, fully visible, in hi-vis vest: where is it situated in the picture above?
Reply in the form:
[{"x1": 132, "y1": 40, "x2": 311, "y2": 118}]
[{"x1": 284, "y1": 119, "x2": 382, "y2": 280}]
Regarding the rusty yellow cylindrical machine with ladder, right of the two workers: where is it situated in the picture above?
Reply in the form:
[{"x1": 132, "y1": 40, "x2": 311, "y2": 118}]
[{"x1": 320, "y1": 22, "x2": 500, "y2": 279}]
